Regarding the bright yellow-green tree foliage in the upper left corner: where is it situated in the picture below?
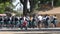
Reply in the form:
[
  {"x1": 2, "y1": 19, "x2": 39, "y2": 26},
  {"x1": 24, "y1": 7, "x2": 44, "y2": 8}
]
[{"x1": 0, "y1": 0, "x2": 11, "y2": 13}]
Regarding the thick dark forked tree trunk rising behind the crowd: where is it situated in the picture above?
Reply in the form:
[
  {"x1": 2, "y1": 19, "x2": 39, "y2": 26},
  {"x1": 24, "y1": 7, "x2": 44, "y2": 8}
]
[{"x1": 20, "y1": 0, "x2": 37, "y2": 15}]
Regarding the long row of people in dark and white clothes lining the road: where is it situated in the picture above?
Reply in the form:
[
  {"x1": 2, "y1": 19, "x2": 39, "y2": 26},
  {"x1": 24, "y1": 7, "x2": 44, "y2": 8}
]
[{"x1": 0, "y1": 14, "x2": 57, "y2": 28}]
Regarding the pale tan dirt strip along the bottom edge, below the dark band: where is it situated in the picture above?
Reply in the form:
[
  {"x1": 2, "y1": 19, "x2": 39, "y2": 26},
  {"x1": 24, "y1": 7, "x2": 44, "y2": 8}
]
[{"x1": 0, "y1": 31, "x2": 60, "y2": 34}]
